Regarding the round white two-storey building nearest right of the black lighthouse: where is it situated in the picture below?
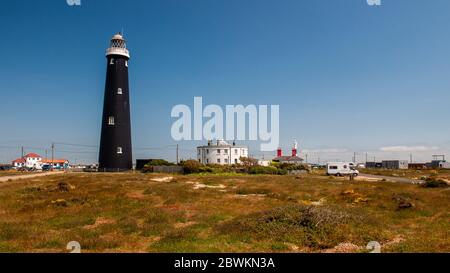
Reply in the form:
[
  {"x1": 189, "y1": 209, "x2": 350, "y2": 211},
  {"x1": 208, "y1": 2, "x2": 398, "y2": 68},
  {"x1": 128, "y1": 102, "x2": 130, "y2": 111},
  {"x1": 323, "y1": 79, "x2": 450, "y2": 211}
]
[{"x1": 197, "y1": 140, "x2": 248, "y2": 165}]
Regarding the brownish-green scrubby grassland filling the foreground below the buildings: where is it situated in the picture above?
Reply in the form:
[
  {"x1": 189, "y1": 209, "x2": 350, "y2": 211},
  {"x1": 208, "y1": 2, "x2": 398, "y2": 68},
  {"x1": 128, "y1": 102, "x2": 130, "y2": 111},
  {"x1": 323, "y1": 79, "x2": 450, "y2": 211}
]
[{"x1": 0, "y1": 173, "x2": 450, "y2": 252}]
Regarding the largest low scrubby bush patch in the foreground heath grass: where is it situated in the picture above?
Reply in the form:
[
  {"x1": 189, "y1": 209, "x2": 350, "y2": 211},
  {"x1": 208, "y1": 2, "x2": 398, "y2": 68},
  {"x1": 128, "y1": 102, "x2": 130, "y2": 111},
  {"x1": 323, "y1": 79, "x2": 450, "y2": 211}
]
[{"x1": 216, "y1": 204, "x2": 378, "y2": 248}]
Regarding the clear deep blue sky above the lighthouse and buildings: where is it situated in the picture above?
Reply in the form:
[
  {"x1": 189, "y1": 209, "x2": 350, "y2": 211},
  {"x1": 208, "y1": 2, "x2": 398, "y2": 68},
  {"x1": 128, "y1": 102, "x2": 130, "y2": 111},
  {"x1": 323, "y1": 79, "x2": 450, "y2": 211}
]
[{"x1": 0, "y1": 0, "x2": 450, "y2": 162}]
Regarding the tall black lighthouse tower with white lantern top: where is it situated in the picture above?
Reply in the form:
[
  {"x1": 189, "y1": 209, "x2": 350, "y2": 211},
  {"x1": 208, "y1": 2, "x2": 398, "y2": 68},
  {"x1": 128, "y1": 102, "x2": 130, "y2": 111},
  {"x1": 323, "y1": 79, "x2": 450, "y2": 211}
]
[{"x1": 99, "y1": 33, "x2": 133, "y2": 172}]
